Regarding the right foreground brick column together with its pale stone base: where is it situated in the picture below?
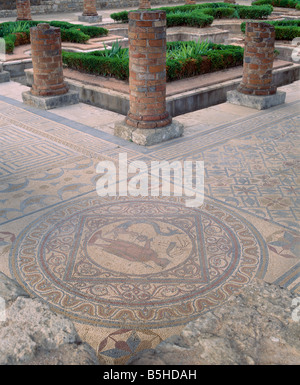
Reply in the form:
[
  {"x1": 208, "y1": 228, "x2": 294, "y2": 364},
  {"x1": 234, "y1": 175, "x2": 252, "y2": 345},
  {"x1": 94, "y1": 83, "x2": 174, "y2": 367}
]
[{"x1": 227, "y1": 22, "x2": 285, "y2": 109}]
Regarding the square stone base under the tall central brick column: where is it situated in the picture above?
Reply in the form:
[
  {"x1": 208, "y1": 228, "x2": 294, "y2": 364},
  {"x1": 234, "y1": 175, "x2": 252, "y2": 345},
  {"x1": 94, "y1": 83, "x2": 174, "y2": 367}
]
[{"x1": 114, "y1": 120, "x2": 184, "y2": 146}]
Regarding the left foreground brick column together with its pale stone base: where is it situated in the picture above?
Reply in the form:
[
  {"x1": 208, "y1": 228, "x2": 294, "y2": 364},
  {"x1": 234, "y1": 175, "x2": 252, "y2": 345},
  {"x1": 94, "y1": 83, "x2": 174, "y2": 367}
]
[{"x1": 22, "y1": 23, "x2": 79, "y2": 109}]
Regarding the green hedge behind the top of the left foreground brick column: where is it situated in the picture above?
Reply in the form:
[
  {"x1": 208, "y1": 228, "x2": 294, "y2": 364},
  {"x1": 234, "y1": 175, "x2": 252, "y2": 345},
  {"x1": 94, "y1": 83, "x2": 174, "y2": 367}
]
[{"x1": 0, "y1": 20, "x2": 108, "y2": 53}]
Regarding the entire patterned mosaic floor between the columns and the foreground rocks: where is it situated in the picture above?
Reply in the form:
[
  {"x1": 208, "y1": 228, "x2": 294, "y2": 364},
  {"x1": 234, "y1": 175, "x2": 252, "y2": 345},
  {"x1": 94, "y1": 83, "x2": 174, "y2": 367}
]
[{"x1": 0, "y1": 83, "x2": 300, "y2": 364}]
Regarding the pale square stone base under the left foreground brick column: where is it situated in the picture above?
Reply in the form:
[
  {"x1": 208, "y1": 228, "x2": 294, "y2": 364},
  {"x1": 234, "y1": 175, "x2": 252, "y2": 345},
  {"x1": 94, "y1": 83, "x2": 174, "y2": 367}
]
[{"x1": 22, "y1": 91, "x2": 79, "y2": 110}]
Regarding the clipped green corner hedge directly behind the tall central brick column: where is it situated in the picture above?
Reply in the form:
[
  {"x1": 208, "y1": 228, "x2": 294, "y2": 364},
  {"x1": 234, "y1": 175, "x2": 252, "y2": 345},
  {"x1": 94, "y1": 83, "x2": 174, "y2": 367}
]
[{"x1": 62, "y1": 41, "x2": 244, "y2": 81}]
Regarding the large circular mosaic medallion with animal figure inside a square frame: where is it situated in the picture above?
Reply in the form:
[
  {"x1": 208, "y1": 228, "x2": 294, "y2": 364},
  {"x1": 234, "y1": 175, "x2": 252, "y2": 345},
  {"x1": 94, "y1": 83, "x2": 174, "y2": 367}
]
[{"x1": 11, "y1": 199, "x2": 267, "y2": 329}]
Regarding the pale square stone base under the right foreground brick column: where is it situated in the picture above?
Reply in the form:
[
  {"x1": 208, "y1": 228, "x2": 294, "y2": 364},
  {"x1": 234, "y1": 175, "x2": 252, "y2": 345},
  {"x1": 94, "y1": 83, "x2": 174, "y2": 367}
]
[{"x1": 227, "y1": 90, "x2": 286, "y2": 110}]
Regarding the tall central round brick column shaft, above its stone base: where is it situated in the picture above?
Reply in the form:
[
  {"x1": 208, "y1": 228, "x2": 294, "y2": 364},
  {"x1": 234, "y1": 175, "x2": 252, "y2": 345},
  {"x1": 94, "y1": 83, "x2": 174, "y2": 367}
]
[{"x1": 125, "y1": 11, "x2": 172, "y2": 128}]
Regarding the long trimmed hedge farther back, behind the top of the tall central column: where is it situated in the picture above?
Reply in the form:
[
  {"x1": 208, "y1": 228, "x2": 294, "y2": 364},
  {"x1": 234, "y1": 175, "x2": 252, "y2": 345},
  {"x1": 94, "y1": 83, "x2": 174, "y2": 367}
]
[{"x1": 110, "y1": 3, "x2": 273, "y2": 27}]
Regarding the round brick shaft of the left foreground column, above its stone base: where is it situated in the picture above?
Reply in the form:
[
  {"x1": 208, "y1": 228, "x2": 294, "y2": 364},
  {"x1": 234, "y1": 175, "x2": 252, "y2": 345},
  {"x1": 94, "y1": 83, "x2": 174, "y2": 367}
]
[{"x1": 30, "y1": 24, "x2": 69, "y2": 96}]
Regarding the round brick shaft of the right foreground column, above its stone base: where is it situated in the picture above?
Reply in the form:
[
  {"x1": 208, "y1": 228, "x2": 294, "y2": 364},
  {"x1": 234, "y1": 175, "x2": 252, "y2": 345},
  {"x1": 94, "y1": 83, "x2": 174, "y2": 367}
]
[{"x1": 237, "y1": 22, "x2": 276, "y2": 96}]
